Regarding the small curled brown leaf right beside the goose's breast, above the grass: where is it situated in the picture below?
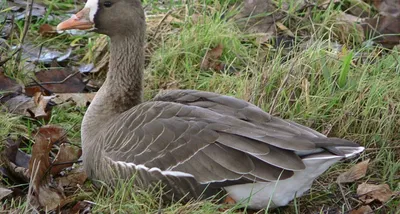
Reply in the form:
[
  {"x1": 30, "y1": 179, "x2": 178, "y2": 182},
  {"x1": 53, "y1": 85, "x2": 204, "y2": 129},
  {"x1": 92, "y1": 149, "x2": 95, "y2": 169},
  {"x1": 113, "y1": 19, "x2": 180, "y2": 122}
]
[{"x1": 51, "y1": 143, "x2": 82, "y2": 175}]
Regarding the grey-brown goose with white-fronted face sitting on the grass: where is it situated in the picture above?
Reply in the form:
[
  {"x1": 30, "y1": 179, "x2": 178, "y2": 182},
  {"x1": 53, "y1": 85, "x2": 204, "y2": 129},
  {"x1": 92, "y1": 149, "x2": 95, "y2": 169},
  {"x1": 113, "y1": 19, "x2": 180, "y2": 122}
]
[{"x1": 57, "y1": 0, "x2": 364, "y2": 209}]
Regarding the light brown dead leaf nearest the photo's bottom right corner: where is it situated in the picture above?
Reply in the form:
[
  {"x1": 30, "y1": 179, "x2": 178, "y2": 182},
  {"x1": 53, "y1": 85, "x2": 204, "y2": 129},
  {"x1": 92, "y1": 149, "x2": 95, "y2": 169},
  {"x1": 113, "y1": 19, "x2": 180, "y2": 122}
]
[{"x1": 357, "y1": 183, "x2": 393, "y2": 204}]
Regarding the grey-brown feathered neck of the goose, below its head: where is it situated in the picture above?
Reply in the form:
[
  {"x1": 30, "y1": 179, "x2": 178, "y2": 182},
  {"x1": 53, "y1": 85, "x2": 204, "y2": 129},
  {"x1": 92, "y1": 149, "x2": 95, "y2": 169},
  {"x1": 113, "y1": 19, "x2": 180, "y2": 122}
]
[{"x1": 82, "y1": 33, "x2": 144, "y2": 143}]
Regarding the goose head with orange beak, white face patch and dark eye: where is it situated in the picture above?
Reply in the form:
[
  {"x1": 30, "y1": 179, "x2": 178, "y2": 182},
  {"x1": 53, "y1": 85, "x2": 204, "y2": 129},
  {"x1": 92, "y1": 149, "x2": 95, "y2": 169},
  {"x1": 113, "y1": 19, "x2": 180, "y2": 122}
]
[{"x1": 57, "y1": 0, "x2": 145, "y2": 37}]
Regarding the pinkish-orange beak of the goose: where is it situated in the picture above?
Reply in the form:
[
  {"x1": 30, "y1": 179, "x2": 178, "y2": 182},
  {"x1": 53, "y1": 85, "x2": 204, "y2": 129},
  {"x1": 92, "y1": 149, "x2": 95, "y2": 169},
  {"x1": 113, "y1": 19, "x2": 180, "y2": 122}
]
[{"x1": 57, "y1": 8, "x2": 94, "y2": 31}]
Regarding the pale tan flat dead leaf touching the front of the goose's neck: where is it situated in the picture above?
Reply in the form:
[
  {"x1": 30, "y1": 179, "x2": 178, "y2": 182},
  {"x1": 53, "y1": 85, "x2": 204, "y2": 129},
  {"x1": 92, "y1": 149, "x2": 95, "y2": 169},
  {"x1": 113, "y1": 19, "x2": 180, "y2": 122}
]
[{"x1": 53, "y1": 92, "x2": 96, "y2": 107}]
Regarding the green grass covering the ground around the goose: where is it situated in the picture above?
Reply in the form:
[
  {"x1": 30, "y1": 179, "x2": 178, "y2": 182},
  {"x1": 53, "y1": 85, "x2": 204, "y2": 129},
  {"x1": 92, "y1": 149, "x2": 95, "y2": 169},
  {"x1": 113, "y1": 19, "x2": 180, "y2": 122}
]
[{"x1": 0, "y1": 0, "x2": 400, "y2": 213}]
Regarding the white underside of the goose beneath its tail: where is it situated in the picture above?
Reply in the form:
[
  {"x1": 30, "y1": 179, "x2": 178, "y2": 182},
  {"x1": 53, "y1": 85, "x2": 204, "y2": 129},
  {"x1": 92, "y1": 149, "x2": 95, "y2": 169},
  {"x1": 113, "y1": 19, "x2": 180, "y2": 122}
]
[{"x1": 225, "y1": 156, "x2": 341, "y2": 209}]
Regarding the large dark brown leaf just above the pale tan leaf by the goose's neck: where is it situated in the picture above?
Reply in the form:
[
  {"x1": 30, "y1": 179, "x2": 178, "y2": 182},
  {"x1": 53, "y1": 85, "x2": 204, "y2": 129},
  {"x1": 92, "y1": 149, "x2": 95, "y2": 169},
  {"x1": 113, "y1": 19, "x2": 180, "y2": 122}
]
[{"x1": 25, "y1": 69, "x2": 85, "y2": 96}]
